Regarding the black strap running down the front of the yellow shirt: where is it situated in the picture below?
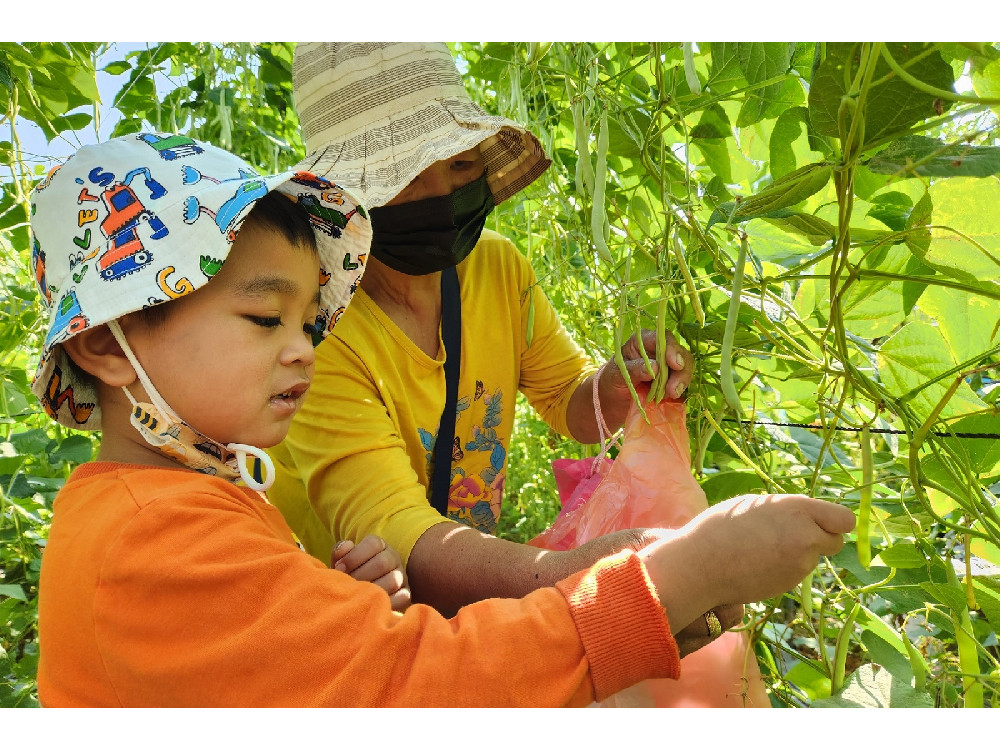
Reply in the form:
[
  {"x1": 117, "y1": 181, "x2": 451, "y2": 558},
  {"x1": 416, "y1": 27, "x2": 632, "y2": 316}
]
[{"x1": 431, "y1": 266, "x2": 462, "y2": 516}]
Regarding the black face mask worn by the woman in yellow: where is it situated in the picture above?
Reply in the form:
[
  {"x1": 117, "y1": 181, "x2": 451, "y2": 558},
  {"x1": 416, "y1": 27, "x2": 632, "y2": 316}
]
[{"x1": 368, "y1": 174, "x2": 493, "y2": 276}]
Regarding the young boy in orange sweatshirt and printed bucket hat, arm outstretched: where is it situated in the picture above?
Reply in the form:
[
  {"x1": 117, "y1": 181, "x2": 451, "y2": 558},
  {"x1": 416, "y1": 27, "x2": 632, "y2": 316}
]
[{"x1": 32, "y1": 134, "x2": 854, "y2": 706}]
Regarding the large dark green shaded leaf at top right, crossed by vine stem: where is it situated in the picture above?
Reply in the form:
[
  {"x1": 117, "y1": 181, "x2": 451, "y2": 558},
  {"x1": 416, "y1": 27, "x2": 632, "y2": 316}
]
[{"x1": 809, "y1": 42, "x2": 955, "y2": 143}]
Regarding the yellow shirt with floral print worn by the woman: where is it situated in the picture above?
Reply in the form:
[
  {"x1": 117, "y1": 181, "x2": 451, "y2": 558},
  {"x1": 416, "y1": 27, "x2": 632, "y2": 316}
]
[{"x1": 269, "y1": 230, "x2": 596, "y2": 563}]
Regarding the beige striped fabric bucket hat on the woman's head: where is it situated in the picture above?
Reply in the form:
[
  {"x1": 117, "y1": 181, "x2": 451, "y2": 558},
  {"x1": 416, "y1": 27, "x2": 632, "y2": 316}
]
[{"x1": 292, "y1": 42, "x2": 551, "y2": 207}]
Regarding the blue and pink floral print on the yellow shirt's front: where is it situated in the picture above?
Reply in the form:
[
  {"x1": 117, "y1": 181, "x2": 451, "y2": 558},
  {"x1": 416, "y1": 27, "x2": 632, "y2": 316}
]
[{"x1": 418, "y1": 380, "x2": 507, "y2": 534}]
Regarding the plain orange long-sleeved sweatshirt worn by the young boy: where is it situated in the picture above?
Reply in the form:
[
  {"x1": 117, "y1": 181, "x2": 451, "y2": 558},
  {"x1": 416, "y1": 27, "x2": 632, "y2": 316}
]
[{"x1": 38, "y1": 463, "x2": 680, "y2": 706}]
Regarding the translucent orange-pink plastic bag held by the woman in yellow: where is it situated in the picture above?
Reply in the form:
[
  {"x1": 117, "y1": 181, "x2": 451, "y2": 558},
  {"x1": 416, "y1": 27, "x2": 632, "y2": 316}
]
[{"x1": 529, "y1": 391, "x2": 770, "y2": 708}]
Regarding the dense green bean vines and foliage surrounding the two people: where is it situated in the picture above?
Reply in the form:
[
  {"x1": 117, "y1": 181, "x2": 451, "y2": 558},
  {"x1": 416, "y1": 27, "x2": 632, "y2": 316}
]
[{"x1": 0, "y1": 42, "x2": 1000, "y2": 706}]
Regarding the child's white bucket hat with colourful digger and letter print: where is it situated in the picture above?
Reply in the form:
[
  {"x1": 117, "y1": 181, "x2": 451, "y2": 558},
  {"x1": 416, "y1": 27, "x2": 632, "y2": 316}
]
[{"x1": 31, "y1": 133, "x2": 372, "y2": 430}]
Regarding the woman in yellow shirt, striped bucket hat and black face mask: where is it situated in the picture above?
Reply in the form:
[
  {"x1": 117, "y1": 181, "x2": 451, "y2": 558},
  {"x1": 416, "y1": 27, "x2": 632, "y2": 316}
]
[{"x1": 271, "y1": 42, "x2": 693, "y2": 612}]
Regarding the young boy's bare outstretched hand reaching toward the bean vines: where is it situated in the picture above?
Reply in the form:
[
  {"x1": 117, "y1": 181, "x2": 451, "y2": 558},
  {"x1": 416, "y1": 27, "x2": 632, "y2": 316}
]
[{"x1": 639, "y1": 495, "x2": 855, "y2": 633}]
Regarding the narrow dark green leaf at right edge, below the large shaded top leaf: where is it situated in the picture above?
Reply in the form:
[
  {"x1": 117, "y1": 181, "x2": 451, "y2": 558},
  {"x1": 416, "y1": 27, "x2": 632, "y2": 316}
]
[{"x1": 868, "y1": 135, "x2": 1000, "y2": 177}]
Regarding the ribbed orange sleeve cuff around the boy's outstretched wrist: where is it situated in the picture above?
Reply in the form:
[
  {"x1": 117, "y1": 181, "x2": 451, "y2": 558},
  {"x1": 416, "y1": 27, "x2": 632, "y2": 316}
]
[{"x1": 556, "y1": 550, "x2": 681, "y2": 700}]
